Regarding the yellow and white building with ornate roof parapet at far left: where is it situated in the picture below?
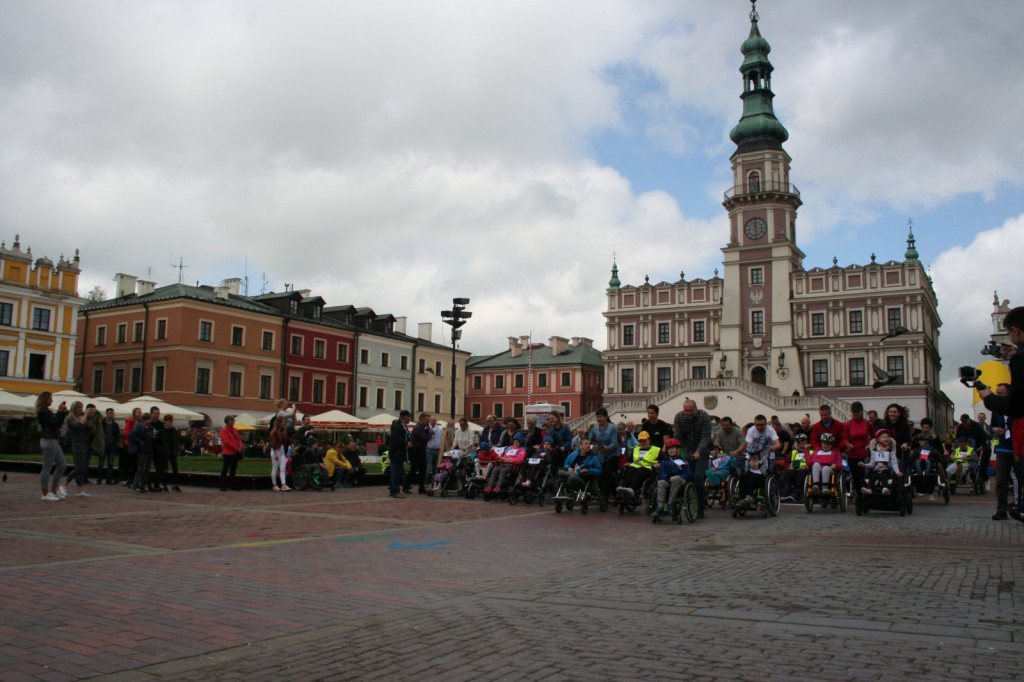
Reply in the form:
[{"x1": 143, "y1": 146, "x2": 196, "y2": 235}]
[{"x1": 0, "y1": 236, "x2": 85, "y2": 393}]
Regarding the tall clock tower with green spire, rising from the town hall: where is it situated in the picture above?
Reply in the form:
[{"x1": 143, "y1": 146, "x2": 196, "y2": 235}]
[{"x1": 721, "y1": 0, "x2": 804, "y2": 395}]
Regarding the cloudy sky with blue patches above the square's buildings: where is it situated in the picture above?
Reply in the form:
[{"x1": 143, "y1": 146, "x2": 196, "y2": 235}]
[{"x1": 0, "y1": 0, "x2": 1024, "y2": 408}]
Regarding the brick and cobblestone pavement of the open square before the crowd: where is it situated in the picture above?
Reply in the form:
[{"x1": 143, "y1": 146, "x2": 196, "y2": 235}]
[{"x1": 0, "y1": 466, "x2": 1024, "y2": 682}]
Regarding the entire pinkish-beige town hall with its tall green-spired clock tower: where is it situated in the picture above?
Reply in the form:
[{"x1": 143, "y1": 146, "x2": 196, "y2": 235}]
[{"x1": 604, "y1": 5, "x2": 949, "y2": 422}]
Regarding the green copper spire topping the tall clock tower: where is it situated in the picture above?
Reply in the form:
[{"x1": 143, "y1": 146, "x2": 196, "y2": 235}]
[{"x1": 729, "y1": 0, "x2": 790, "y2": 148}]
